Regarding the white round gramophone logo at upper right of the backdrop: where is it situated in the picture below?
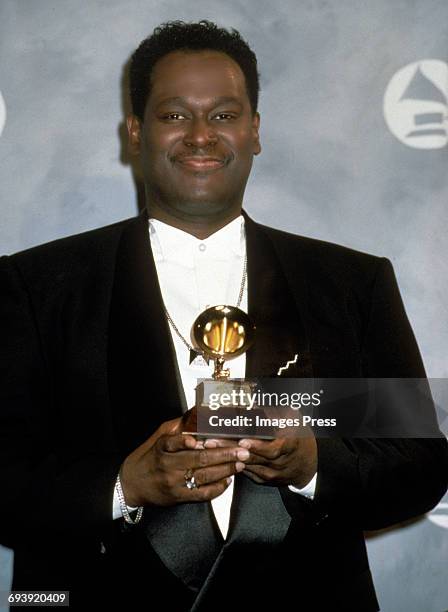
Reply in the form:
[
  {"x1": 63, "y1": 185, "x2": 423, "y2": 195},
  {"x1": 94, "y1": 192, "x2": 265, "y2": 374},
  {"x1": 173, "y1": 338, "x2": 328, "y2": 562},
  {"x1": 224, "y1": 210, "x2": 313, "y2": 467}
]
[{"x1": 383, "y1": 59, "x2": 448, "y2": 149}]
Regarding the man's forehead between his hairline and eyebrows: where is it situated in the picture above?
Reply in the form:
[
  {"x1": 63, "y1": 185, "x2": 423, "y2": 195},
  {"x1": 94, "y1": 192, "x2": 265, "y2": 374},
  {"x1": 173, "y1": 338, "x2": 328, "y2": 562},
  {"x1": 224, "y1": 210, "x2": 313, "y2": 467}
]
[{"x1": 150, "y1": 51, "x2": 249, "y2": 105}]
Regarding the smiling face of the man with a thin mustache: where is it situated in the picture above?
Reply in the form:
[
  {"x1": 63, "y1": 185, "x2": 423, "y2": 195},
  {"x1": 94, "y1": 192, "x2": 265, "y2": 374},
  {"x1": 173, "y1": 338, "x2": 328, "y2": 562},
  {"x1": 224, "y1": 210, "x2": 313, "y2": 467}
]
[{"x1": 128, "y1": 51, "x2": 260, "y2": 219}]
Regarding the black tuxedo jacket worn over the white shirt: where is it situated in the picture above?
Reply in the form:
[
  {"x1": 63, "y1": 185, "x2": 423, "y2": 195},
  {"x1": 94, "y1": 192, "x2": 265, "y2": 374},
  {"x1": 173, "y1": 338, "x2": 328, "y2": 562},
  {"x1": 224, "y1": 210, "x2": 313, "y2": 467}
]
[{"x1": 0, "y1": 209, "x2": 448, "y2": 612}]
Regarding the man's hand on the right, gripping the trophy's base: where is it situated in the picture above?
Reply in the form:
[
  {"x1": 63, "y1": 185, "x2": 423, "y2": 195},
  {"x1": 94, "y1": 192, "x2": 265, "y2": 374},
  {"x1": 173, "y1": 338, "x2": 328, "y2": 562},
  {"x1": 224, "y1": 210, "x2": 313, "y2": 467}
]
[{"x1": 239, "y1": 430, "x2": 317, "y2": 488}]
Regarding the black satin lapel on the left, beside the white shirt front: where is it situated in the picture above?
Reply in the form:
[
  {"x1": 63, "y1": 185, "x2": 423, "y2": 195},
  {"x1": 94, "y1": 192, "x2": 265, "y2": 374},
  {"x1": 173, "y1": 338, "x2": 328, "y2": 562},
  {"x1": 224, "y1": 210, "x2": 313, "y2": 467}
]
[{"x1": 108, "y1": 214, "x2": 182, "y2": 453}]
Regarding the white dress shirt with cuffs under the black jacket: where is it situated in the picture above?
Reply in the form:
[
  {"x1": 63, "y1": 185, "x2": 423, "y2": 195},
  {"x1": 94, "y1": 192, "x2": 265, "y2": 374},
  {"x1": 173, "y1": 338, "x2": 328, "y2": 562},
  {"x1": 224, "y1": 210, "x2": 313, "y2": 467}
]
[{"x1": 113, "y1": 215, "x2": 317, "y2": 538}]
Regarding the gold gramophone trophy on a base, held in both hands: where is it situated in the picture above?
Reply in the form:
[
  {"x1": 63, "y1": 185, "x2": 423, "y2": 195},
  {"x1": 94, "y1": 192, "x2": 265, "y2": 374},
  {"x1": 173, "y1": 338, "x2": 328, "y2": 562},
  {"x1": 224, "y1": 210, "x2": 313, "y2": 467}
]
[{"x1": 183, "y1": 305, "x2": 256, "y2": 438}]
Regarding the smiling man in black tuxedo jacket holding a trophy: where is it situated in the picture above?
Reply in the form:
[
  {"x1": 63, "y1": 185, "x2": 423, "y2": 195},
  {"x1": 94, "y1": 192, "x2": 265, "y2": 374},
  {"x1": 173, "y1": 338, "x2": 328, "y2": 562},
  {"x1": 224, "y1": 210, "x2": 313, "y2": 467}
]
[{"x1": 0, "y1": 22, "x2": 448, "y2": 611}]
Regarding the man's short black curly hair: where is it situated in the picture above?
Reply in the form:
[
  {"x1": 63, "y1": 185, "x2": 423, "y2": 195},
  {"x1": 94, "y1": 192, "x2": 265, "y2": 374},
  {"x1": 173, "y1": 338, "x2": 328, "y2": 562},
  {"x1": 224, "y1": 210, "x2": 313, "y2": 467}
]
[{"x1": 129, "y1": 19, "x2": 260, "y2": 121}]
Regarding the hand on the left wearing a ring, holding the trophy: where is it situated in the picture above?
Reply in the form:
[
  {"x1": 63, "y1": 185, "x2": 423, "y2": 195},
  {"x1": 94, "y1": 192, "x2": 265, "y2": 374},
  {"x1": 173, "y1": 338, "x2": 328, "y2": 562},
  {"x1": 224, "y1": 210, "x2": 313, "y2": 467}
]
[{"x1": 120, "y1": 418, "x2": 249, "y2": 506}]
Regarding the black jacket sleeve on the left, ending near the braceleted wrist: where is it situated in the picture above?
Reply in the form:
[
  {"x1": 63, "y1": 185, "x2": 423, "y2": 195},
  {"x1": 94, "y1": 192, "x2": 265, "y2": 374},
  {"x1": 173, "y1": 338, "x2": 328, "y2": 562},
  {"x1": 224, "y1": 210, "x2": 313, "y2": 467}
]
[{"x1": 0, "y1": 257, "x2": 123, "y2": 547}]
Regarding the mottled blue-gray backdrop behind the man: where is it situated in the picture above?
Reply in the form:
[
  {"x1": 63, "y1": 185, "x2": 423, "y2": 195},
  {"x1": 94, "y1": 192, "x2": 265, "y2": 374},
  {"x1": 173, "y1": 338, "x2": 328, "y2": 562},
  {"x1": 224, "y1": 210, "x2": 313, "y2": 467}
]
[{"x1": 0, "y1": 0, "x2": 448, "y2": 612}]
